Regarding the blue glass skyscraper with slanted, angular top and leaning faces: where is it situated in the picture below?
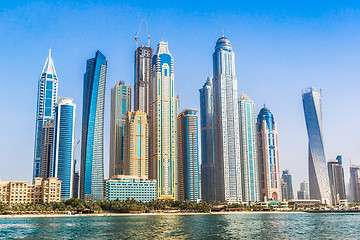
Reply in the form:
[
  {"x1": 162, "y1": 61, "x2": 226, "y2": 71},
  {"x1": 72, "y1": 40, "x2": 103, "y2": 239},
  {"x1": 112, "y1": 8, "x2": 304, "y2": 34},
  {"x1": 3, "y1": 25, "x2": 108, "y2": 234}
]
[{"x1": 80, "y1": 51, "x2": 107, "y2": 200}]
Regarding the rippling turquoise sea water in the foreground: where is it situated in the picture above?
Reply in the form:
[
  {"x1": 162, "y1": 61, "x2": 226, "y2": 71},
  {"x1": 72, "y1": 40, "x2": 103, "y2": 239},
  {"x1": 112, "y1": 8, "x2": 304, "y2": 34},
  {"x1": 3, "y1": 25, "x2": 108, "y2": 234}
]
[{"x1": 0, "y1": 213, "x2": 360, "y2": 239}]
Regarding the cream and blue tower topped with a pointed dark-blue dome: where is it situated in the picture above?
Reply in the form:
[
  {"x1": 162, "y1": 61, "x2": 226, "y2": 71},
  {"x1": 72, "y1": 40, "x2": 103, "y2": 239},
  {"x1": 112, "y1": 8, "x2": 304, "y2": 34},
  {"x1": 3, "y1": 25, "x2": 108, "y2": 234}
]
[{"x1": 257, "y1": 107, "x2": 282, "y2": 201}]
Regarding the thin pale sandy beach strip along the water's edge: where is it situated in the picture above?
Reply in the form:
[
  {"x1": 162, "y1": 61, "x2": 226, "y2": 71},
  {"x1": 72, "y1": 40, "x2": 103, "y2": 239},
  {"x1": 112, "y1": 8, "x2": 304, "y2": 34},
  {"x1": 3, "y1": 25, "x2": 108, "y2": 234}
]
[{"x1": 0, "y1": 211, "x2": 306, "y2": 218}]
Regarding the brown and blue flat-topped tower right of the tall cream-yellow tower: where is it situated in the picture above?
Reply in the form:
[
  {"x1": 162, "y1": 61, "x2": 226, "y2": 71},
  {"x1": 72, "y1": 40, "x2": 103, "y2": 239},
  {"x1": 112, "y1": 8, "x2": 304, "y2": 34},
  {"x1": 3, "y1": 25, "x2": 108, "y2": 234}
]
[{"x1": 177, "y1": 109, "x2": 200, "y2": 201}]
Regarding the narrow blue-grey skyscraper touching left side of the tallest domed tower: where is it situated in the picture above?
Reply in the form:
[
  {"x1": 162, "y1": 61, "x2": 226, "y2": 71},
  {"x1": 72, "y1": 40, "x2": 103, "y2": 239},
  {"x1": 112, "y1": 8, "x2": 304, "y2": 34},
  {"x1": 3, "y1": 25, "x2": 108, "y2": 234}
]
[{"x1": 199, "y1": 77, "x2": 216, "y2": 202}]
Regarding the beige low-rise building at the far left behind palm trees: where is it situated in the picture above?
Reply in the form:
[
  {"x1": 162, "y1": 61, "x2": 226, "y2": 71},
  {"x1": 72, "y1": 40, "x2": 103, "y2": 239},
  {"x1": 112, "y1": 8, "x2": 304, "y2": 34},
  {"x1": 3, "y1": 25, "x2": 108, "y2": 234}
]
[{"x1": 0, "y1": 177, "x2": 61, "y2": 205}]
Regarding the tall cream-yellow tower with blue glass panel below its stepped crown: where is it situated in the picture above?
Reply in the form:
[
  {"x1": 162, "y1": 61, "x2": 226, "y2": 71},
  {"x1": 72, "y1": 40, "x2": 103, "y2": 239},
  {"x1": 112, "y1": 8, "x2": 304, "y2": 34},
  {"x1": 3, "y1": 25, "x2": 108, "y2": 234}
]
[{"x1": 149, "y1": 41, "x2": 177, "y2": 199}]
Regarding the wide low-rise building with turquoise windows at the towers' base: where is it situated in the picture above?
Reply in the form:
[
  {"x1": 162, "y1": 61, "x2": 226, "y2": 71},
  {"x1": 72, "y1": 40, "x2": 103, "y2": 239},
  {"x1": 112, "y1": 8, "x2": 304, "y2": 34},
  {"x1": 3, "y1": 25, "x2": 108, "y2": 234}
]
[{"x1": 105, "y1": 175, "x2": 157, "y2": 202}]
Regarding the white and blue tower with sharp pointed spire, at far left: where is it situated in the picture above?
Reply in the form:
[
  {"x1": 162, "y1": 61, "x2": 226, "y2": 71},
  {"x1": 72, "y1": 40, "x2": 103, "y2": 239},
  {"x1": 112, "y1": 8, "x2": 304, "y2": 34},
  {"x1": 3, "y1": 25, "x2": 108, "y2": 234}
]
[{"x1": 33, "y1": 49, "x2": 58, "y2": 178}]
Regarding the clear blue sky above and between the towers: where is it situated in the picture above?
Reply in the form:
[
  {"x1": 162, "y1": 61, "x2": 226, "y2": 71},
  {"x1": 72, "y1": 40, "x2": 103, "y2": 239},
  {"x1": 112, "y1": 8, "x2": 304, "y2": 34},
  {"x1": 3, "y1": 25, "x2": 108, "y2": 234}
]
[{"x1": 0, "y1": 1, "x2": 360, "y2": 191}]
